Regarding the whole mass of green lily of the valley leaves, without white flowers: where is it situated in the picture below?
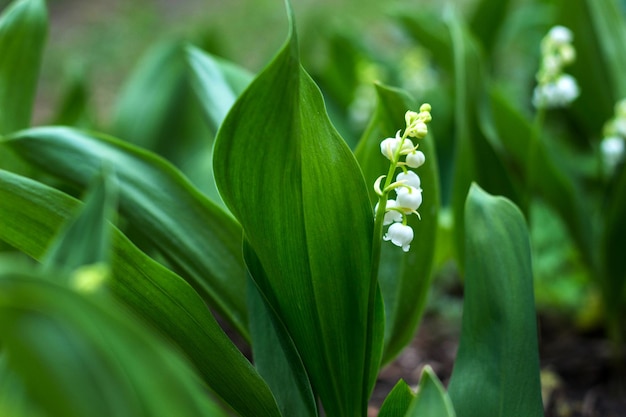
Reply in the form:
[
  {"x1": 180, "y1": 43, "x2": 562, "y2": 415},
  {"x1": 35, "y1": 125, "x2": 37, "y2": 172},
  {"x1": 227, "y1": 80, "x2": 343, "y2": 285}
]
[{"x1": 0, "y1": 0, "x2": 626, "y2": 417}]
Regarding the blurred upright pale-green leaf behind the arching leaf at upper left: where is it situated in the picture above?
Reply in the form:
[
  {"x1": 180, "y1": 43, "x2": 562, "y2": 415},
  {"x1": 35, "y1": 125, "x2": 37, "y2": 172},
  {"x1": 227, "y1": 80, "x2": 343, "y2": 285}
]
[{"x1": 112, "y1": 40, "x2": 220, "y2": 202}]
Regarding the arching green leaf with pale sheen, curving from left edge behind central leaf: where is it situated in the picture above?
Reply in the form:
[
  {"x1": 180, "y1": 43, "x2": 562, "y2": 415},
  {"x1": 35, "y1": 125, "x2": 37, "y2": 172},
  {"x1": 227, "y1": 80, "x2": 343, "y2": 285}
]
[{"x1": 0, "y1": 127, "x2": 247, "y2": 336}]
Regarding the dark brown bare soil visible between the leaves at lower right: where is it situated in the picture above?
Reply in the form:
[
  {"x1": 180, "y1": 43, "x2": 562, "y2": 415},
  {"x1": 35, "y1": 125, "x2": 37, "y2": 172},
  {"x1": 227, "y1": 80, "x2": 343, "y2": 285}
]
[{"x1": 370, "y1": 314, "x2": 626, "y2": 417}]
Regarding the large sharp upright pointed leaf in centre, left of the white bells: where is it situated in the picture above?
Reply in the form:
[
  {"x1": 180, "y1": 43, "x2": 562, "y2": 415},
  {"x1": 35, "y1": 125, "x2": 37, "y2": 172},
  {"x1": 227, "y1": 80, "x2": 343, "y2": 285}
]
[{"x1": 213, "y1": 7, "x2": 382, "y2": 417}]
